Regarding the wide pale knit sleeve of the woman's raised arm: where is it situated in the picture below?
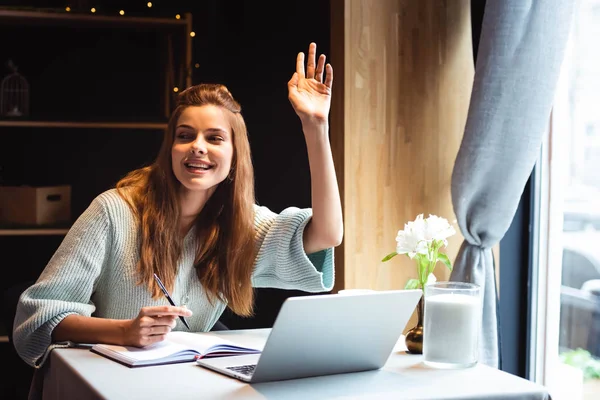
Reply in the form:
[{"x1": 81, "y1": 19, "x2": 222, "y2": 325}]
[{"x1": 252, "y1": 206, "x2": 334, "y2": 293}]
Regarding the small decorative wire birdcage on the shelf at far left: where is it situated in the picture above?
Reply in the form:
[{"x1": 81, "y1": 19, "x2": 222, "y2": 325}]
[{"x1": 0, "y1": 60, "x2": 29, "y2": 117}]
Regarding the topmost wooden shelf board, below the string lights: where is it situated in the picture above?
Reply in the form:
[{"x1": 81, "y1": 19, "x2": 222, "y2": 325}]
[{"x1": 0, "y1": 8, "x2": 188, "y2": 28}]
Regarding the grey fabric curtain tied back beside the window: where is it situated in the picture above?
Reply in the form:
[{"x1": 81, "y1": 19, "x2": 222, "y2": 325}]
[{"x1": 450, "y1": 0, "x2": 576, "y2": 367}]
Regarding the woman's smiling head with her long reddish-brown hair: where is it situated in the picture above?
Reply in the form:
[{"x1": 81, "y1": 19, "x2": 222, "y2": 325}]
[{"x1": 117, "y1": 84, "x2": 256, "y2": 316}]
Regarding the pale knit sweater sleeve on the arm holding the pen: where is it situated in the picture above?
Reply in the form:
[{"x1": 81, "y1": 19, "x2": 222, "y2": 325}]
[{"x1": 13, "y1": 195, "x2": 110, "y2": 367}]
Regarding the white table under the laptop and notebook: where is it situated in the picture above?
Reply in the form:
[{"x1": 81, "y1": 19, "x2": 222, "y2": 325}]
[{"x1": 43, "y1": 329, "x2": 549, "y2": 400}]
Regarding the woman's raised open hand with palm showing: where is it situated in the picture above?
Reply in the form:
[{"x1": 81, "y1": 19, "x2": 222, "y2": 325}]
[{"x1": 288, "y1": 43, "x2": 333, "y2": 124}]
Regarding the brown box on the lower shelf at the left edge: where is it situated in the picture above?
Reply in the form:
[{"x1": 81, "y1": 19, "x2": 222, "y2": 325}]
[{"x1": 0, "y1": 185, "x2": 71, "y2": 226}]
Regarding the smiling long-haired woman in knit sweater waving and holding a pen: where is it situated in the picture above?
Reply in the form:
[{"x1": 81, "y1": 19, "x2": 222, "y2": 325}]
[{"x1": 13, "y1": 43, "x2": 343, "y2": 367}]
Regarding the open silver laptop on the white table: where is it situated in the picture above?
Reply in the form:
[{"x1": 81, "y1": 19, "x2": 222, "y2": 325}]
[{"x1": 196, "y1": 289, "x2": 422, "y2": 383}]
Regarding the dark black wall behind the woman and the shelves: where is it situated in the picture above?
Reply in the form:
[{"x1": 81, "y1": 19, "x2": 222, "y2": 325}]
[{"x1": 0, "y1": 0, "x2": 335, "y2": 398}]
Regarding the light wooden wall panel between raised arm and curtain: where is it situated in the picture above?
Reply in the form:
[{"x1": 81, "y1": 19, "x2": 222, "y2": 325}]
[{"x1": 331, "y1": 0, "x2": 474, "y2": 290}]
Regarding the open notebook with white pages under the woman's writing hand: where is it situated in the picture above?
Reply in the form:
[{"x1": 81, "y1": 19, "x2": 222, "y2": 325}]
[{"x1": 91, "y1": 331, "x2": 260, "y2": 367}]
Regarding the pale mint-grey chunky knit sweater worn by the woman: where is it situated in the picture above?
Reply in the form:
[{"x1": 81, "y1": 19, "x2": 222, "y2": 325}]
[{"x1": 13, "y1": 189, "x2": 334, "y2": 367}]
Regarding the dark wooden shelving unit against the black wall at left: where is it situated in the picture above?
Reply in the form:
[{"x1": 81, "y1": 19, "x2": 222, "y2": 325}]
[{"x1": 0, "y1": 8, "x2": 192, "y2": 343}]
